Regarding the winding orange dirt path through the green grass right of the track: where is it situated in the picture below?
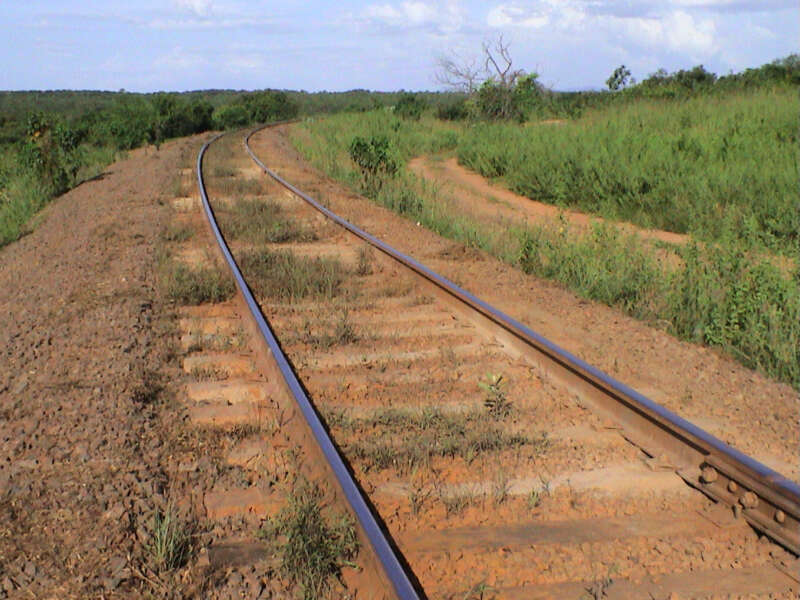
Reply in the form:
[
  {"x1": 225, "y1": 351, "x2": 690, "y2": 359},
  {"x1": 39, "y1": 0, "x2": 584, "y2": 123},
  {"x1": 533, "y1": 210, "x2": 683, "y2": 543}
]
[{"x1": 408, "y1": 156, "x2": 689, "y2": 244}]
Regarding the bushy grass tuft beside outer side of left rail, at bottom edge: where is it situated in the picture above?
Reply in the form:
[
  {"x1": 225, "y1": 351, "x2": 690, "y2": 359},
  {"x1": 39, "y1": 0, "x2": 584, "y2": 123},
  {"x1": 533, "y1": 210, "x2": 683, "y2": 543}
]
[{"x1": 261, "y1": 481, "x2": 359, "y2": 600}]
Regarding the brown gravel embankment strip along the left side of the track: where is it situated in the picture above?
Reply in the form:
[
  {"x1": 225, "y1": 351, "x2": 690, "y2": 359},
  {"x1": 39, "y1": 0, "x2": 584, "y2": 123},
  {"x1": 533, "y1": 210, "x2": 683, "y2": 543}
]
[{"x1": 0, "y1": 138, "x2": 214, "y2": 598}]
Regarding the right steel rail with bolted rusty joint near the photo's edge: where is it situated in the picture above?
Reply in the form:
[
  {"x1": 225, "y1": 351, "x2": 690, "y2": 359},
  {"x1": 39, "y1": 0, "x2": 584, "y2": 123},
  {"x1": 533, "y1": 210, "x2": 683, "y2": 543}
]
[{"x1": 244, "y1": 124, "x2": 800, "y2": 554}]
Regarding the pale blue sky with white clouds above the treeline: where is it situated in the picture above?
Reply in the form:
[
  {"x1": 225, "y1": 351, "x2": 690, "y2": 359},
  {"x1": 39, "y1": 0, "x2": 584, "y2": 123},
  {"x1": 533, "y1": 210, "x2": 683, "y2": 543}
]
[{"x1": 0, "y1": 0, "x2": 800, "y2": 92}]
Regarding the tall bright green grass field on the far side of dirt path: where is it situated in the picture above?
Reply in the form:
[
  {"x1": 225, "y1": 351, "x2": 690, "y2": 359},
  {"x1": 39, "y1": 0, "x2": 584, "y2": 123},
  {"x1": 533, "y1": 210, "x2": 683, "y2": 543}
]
[{"x1": 458, "y1": 87, "x2": 800, "y2": 254}]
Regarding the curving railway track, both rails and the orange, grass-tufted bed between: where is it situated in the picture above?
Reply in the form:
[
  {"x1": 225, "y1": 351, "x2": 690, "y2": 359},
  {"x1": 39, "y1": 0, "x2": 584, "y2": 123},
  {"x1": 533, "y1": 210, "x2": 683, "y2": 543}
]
[{"x1": 198, "y1": 123, "x2": 800, "y2": 598}]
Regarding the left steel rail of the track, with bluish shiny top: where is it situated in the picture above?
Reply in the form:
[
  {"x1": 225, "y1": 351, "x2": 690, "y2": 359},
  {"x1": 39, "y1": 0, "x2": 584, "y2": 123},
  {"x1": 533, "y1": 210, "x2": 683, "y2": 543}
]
[{"x1": 197, "y1": 129, "x2": 419, "y2": 600}]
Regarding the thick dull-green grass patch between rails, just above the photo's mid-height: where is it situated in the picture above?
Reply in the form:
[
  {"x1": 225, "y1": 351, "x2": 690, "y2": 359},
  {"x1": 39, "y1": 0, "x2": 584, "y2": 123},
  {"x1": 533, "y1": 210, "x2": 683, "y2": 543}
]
[{"x1": 239, "y1": 249, "x2": 347, "y2": 300}]
